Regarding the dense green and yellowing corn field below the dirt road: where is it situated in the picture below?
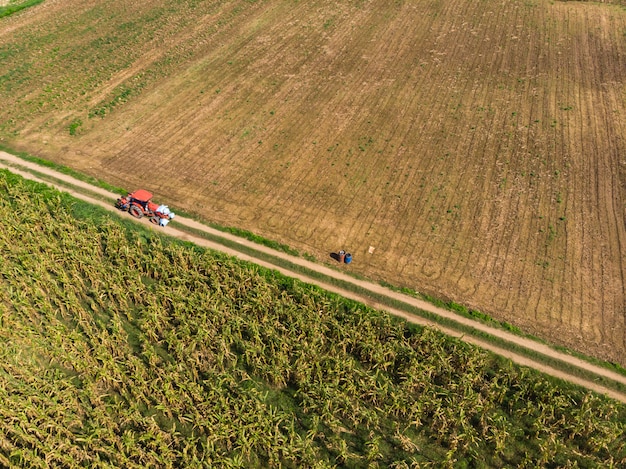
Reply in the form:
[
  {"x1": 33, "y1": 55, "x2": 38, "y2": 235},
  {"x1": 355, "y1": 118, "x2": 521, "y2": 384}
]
[{"x1": 0, "y1": 172, "x2": 626, "y2": 468}]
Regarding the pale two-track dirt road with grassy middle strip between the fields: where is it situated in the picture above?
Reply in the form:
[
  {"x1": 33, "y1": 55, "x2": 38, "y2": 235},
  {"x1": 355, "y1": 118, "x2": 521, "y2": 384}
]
[{"x1": 0, "y1": 152, "x2": 626, "y2": 403}]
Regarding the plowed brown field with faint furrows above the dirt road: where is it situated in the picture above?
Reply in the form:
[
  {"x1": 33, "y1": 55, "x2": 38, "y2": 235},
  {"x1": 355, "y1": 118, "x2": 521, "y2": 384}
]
[{"x1": 0, "y1": 0, "x2": 626, "y2": 365}]
